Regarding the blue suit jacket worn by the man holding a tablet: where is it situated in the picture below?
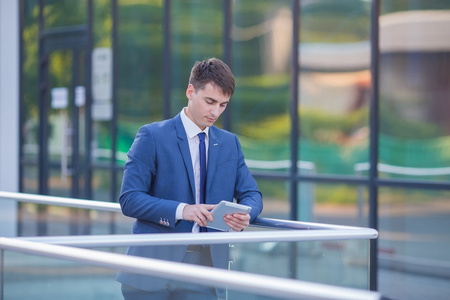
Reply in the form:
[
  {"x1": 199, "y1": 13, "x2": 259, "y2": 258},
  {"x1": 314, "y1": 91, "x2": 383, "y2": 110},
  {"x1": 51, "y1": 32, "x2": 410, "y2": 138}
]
[{"x1": 117, "y1": 115, "x2": 263, "y2": 291}]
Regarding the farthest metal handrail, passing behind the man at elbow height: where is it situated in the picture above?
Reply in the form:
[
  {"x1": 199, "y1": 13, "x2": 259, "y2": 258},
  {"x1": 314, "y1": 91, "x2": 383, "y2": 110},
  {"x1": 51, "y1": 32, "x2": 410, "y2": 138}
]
[{"x1": 0, "y1": 191, "x2": 378, "y2": 234}]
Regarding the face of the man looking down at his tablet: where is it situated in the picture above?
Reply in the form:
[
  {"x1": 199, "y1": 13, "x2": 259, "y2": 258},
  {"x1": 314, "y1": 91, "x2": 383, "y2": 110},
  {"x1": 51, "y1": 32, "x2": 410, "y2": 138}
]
[{"x1": 186, "y1": 83, "x2": 230, "y2": 130}]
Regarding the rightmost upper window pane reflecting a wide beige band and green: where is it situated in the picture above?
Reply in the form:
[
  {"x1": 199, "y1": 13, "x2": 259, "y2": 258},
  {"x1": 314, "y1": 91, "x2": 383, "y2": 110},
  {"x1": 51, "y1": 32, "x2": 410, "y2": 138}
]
[{"x1": 379, "y1": 7, "x2": 450, "y2": 181}]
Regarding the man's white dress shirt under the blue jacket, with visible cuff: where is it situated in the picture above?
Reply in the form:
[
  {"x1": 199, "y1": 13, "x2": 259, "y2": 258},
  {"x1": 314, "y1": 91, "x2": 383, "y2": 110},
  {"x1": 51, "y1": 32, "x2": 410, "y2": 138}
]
[{"x1": 175, "y1": 108, "x2": 209, "y2": 232}]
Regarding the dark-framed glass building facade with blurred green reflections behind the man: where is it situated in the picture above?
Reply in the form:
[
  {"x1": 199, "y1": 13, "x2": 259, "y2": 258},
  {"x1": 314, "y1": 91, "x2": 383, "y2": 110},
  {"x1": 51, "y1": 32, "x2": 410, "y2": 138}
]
[{"x1": 13, "y1": 0, "x2": 450, "y2": 299}]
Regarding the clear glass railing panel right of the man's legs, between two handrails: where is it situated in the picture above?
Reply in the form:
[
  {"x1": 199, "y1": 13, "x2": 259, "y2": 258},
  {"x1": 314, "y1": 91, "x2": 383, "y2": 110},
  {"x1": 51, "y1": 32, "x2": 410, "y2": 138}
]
[{"x1": 230, "y1": 240, "x2": 369, "y2": 289}]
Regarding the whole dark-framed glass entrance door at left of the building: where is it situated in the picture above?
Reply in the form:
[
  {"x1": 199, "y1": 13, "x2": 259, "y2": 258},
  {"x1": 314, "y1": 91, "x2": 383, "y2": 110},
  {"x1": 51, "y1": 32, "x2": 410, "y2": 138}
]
[{"x1": 38, "y1": 27, "x2": 90, "y2": 198}]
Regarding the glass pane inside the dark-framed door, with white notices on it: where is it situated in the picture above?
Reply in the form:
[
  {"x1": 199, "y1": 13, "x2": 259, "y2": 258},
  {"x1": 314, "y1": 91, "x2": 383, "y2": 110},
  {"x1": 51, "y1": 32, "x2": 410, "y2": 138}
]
[{"x1": 42, "y1": 48, "x2": 86, "y2": 198}]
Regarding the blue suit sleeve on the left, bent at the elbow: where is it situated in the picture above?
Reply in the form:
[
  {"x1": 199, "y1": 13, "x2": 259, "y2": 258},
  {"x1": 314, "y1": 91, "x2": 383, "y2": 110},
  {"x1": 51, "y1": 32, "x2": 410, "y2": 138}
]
[{"x1": 119, "y1": 126, "x2": 180, "y2": 228}]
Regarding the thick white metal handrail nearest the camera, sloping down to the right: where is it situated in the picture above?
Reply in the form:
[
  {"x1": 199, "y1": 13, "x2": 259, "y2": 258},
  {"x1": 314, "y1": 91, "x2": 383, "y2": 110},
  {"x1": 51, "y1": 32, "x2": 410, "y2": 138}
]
[{"x1": 0, "y1": 237, "x2": 381, "y2": 300}]
